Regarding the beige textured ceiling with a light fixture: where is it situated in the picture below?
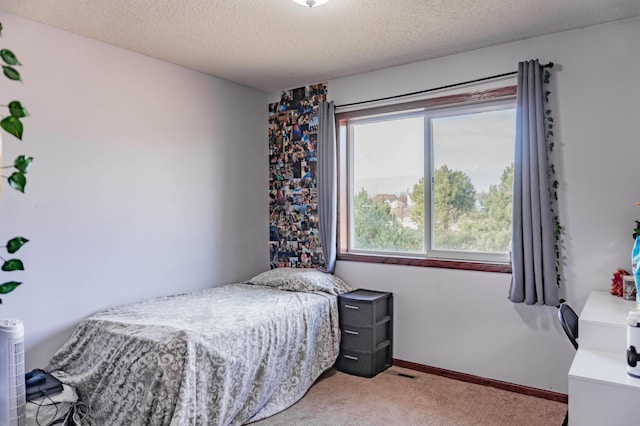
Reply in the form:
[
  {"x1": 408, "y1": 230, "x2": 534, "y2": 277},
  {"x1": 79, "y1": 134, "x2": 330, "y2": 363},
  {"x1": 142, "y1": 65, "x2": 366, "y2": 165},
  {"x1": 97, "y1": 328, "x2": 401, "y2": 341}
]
[{"x1": 0, "y1": 0, "x2": 640, "y2": 92}]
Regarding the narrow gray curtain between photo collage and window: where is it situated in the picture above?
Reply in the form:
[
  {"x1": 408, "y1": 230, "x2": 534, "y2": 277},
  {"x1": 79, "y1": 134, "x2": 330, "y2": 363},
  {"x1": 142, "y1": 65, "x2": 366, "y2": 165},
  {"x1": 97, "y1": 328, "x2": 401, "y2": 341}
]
[{"x1": 316, "y1": 101, "x2": 338, "y2": 273}]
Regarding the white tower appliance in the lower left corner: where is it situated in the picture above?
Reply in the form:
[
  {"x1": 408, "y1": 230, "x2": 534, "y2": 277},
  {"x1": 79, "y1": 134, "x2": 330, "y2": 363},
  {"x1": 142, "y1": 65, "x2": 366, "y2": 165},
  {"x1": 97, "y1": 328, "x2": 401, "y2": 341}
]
[{"x1": 0, "y1": 319, "x2": 27, "y2": 426}]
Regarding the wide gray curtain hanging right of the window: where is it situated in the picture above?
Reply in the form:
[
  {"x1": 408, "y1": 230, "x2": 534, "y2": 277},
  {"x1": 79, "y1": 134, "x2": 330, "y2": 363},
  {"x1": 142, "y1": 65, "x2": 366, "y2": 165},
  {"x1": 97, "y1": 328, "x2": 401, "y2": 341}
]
[{"x1": 509, "y1": 60, "x2": 558, "y2": 306}]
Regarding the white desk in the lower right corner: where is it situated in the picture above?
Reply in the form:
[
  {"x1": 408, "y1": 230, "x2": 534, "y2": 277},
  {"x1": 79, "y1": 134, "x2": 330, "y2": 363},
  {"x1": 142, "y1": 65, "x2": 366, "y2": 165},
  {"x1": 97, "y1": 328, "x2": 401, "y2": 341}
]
[{"x1": 569, "y1": 291, "x2": 640, "y2": 426}]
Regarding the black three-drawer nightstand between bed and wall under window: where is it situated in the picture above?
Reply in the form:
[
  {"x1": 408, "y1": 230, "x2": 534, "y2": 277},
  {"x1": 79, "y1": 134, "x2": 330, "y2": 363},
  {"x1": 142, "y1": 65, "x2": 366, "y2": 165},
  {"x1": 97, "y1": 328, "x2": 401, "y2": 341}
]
[{"x1": 336, "y1": 289, "x2": 393, "y2": 377}]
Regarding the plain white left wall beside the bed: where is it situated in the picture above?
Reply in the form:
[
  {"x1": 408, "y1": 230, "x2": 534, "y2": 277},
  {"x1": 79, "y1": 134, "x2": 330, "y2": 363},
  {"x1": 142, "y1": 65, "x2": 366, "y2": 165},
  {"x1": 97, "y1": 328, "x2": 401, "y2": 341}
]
[{"x1": 0, "y1": 13, "x2": 269, "y2": 369}]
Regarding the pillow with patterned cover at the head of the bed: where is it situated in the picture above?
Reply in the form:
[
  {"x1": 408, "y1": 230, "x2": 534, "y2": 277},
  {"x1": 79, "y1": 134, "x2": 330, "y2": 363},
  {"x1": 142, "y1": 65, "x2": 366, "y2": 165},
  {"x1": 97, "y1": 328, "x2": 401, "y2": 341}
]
[{"x1": 244, "y1": 268, "x2": 354, "y2": 296}]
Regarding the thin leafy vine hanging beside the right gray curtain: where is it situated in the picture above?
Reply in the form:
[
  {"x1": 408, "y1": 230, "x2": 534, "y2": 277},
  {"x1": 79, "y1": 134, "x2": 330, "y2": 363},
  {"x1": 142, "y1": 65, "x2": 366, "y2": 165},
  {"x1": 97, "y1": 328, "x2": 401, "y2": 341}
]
[{"x1": 543, "y1": 64, "x2": 564, "y2": 303}]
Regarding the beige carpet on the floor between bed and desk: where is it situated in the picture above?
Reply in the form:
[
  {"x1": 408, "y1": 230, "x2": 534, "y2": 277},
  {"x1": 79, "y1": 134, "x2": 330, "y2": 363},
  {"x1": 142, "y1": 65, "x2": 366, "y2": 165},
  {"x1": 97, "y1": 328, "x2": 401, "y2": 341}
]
[{"x1": 251, "y1": 367, "x2": 567, "y2": 426}]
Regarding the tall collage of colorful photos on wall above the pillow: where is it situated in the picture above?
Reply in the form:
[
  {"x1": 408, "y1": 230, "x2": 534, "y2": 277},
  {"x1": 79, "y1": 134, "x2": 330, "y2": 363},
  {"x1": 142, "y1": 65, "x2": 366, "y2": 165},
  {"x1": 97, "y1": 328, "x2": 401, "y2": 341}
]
[{"x1": 269, "y1": 83, "x2": 327, "y2": 269}]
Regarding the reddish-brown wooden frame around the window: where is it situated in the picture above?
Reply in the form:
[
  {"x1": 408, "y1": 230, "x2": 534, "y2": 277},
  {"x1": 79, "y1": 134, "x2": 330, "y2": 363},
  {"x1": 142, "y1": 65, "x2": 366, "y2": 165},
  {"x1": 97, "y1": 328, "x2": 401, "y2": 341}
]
[{"x1": 336, "y1": 86, "x2": 516, "y2": 273}]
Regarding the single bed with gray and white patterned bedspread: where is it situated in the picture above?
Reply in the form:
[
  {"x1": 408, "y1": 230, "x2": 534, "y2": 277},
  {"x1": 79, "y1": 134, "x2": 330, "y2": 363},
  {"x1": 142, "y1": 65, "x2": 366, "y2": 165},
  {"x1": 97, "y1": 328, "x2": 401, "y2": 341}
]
[{"x1": 47, "y1": 268, "x2": 352, "y2": 426}]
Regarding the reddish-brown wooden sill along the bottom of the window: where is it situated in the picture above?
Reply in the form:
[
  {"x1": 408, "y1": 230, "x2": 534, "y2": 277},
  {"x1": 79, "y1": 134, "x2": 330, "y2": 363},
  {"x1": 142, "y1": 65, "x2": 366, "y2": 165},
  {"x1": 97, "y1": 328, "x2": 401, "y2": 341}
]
[{"x1": 336, "y1": 253, "x2": 511, "y2": 274}]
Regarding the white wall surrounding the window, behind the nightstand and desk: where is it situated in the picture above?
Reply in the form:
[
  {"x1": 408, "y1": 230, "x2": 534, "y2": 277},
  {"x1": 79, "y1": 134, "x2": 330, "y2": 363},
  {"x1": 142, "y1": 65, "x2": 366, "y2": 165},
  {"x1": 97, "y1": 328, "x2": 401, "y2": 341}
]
[{"x1": 280, "y1": 18, "x2": 640, "y2": 393}]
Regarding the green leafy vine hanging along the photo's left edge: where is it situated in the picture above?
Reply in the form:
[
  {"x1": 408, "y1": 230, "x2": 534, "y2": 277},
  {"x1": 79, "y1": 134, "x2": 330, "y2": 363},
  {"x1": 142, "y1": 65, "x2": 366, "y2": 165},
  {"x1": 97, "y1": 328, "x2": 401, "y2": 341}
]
[{"x1": 0, "y1": 23, "x2": 33, "y2": 303}]
